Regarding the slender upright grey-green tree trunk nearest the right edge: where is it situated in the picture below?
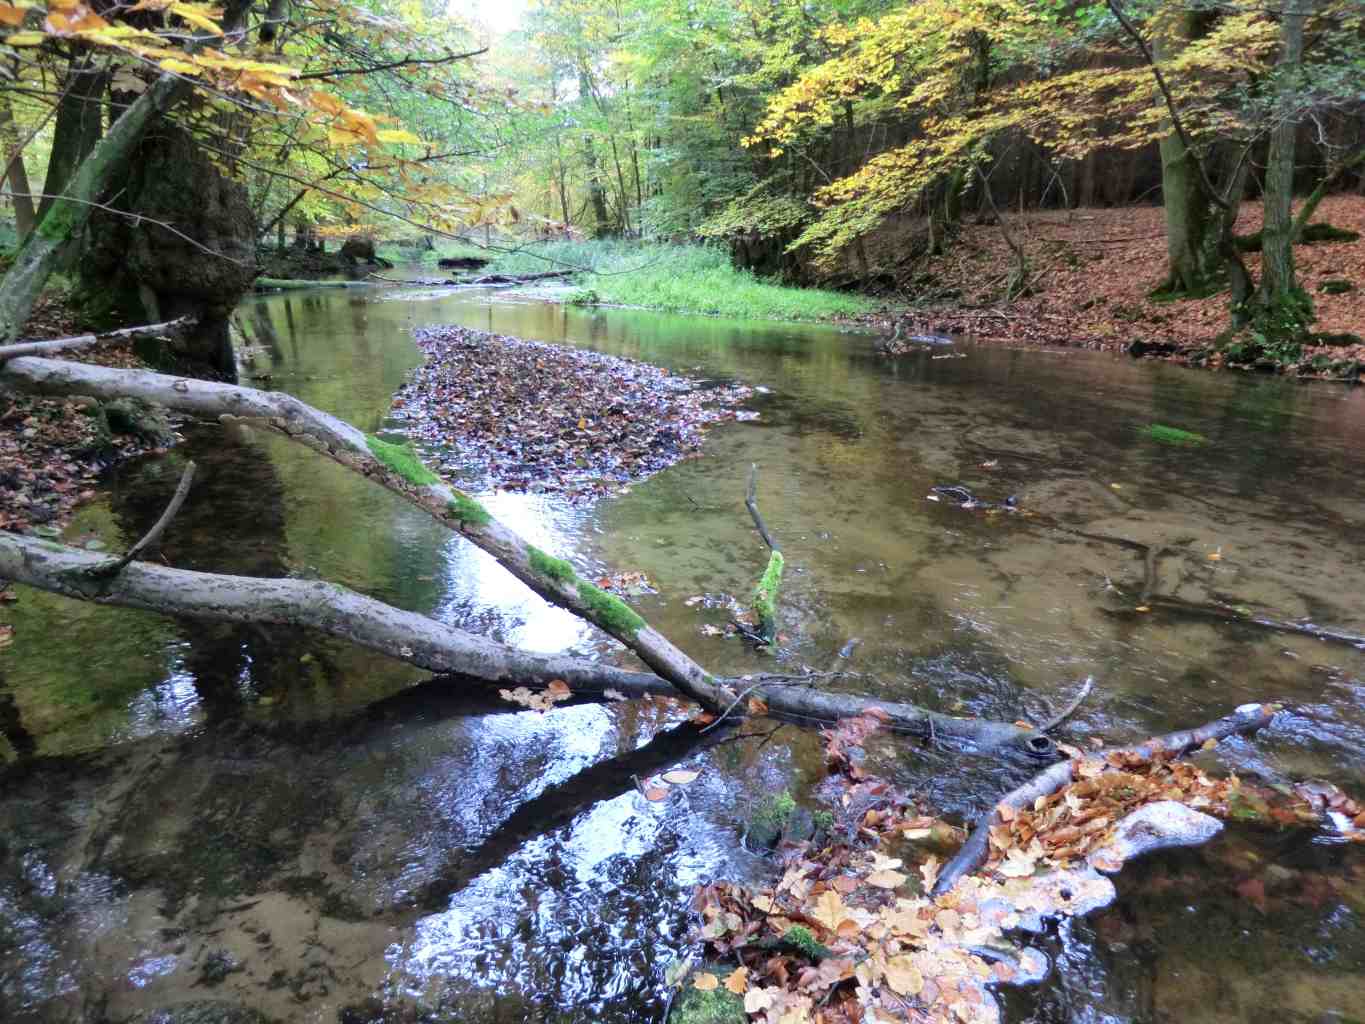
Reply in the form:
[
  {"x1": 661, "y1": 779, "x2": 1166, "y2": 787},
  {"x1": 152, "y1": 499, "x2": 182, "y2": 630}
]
[{"x1": 1261, "y1": 0, "x2": 1312, "y2": 311}]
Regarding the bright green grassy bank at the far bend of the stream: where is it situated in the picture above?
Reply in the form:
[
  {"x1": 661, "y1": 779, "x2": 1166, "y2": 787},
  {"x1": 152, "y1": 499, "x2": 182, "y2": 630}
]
[{"x1": 386, "y1": 242, "x2": 875, "y2": 319}]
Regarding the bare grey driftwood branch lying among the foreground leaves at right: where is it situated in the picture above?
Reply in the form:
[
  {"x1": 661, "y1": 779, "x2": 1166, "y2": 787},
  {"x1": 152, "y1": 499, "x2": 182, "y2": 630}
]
[{"x1": 932, "y1": 705, "x2": 1279, "y2": 896}]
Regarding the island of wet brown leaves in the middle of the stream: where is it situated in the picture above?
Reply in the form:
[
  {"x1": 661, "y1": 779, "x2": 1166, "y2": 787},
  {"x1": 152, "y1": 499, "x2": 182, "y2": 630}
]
[{"x1": 393, "y1": 326, "x2": 752, "y2": 497}]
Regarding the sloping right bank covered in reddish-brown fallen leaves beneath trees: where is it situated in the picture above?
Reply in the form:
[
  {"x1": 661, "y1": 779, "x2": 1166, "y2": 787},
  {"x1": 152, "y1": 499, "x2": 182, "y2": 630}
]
[{"x1": 854, "y1": 195, "x2": 1365, "y2": 375}]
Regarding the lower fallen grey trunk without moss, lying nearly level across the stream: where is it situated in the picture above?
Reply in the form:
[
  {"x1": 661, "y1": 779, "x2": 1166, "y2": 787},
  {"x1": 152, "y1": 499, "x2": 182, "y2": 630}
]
[{"x1": 0, "y1": 531, "x2": 1057, "y2": 760}]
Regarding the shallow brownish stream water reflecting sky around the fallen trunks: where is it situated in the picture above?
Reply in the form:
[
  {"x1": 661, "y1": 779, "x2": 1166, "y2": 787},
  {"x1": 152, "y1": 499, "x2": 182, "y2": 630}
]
[{"x1": 0, "y1": 281, "x2": 1365, "y2": 1023}]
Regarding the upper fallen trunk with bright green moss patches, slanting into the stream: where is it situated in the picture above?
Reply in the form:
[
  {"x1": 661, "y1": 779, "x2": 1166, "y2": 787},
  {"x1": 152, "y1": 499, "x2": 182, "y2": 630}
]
[{"x1": 0, "y1": 356, "x2": 734, "y2": 711}]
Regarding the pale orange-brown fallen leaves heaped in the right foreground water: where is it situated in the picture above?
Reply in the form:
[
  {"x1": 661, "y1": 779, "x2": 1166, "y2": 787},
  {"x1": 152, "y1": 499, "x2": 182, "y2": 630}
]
[{"x1": 681, "y1": 714, "x2": 1365, "y2": 1024}]
